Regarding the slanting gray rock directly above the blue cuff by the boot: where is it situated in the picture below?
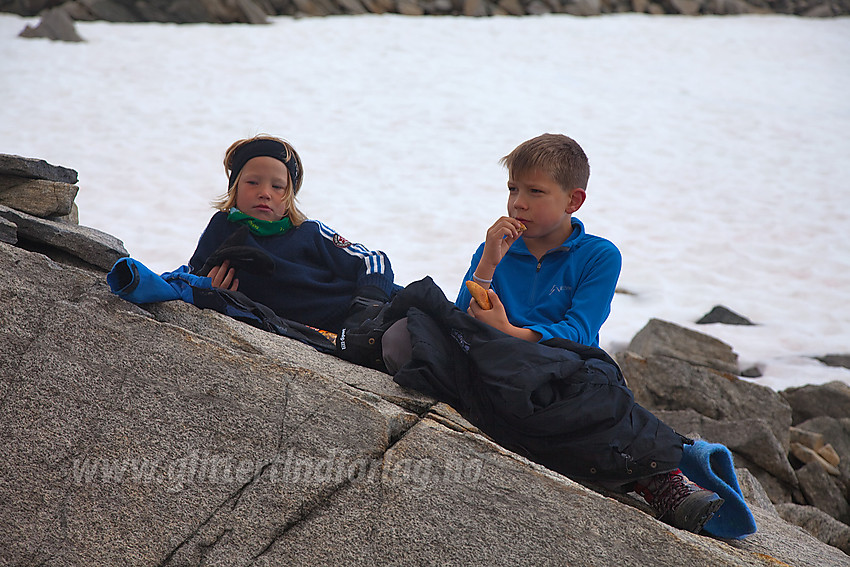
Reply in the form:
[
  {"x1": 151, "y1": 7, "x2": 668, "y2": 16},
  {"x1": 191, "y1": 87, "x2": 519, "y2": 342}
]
[{"x1": 655, "y1": 410, "x2": 797, "y2": 488}]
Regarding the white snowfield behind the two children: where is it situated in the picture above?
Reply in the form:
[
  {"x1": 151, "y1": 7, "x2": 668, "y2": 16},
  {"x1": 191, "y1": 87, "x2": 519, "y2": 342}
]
[{"x1": 0, "y1": 14, "x2": 850, "y2": 390}]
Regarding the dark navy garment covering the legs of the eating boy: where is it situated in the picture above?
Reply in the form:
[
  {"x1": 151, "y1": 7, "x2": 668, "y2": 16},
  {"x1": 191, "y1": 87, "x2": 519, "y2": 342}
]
[{"x1": 338, "y1": 278, "x2": 690, "y2": 485}]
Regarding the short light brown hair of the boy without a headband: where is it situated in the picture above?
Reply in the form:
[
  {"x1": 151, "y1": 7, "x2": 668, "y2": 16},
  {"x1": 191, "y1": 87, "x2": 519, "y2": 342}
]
[{"x1": 499, "y1": 134, "x2": 590, "y2": 191}]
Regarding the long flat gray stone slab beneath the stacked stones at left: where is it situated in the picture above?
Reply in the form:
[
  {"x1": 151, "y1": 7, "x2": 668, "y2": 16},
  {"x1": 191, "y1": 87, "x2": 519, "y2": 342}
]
[{"x1": 0, "y1": 205, "x2": 129, "y2": 271}]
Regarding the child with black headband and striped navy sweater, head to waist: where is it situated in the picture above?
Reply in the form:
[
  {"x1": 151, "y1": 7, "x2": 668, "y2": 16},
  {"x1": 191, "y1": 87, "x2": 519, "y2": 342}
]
[{"x1": 189, "y1": 135, "x2": 398, "y2": 333}]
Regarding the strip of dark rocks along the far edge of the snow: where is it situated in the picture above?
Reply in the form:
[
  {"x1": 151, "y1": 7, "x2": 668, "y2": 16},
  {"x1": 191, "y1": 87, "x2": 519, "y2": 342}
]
[{"x1": 6, "y1": 0, "x2": 850, "y2": 45}]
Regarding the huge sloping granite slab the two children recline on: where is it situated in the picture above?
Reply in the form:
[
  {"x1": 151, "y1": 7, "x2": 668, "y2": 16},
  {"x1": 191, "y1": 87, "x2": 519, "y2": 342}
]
[{"x1": 0, "y1": 244, "x2": 846, "y2": 567}]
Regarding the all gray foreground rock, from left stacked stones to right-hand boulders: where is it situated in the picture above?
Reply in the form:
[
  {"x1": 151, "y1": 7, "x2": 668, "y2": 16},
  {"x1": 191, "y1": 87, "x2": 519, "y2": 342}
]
[{"x1": 0, "y1": 155, "x2": 850, "y2": 566}]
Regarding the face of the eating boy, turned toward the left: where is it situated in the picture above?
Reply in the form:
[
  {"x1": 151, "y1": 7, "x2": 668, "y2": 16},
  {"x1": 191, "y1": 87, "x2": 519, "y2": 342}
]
[{"x1": 508, "y1": 170, "x2": 585, "y2": 249}]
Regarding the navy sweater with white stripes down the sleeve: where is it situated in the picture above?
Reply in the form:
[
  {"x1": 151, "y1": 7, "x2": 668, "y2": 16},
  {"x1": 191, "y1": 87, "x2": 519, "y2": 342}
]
[{"x1": 189, "y1": 212, "x2": 396, "y2": 333}]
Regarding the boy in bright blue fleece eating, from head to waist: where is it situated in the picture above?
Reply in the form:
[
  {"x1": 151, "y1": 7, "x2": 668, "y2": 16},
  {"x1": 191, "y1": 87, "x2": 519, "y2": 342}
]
[{"x1": 455, "y1": 134, "x2": 622, "y2": 347}]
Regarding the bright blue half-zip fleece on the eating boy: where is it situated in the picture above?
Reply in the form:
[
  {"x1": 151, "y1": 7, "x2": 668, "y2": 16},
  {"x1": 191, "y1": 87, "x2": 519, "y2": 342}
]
[{"x1": 455, "y1": 217, "x2": 622, "y2": 347}]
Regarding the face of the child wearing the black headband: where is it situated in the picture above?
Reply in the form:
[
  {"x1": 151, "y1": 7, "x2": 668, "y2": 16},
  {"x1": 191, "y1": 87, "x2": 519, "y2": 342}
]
[{"x1": 236, "y1": 160, "x2": 289, "y2": 221}]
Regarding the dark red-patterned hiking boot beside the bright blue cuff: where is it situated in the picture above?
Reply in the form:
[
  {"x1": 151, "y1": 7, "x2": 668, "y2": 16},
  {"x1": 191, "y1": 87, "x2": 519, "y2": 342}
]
[{"x1": 635, "y1": 469, "x2": 723, "y2": 533}]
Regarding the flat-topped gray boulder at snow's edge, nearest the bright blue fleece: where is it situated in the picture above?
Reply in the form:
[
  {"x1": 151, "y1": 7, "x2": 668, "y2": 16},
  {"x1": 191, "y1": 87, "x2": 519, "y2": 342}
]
[{"x1": 628, "y1": 319, "x2": 738, "y2": 374}]
